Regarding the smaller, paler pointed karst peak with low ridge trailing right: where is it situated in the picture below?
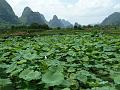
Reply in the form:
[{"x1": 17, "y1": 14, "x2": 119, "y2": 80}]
[{"x1": 49, "y1": 15, "x2": 73, "y2": 28}]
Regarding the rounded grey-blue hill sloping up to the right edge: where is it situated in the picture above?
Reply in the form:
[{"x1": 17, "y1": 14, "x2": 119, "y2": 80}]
[{"x1": 101, "y1": 12, "x2": 120, "y2": 25}]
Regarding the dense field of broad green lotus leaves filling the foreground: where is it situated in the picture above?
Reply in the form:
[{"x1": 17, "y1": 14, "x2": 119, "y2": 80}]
[{"x1": 0, "y1": 30, "x2": 120, "y2": 90}]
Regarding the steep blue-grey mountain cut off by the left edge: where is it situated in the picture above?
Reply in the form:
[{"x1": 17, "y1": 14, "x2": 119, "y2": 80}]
[{"x1": 0, "y1": 0, "x2": 19, "y2": 24}]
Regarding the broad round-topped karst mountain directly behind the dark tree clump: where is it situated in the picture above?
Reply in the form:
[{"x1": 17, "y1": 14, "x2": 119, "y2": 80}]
[{"x1": 19, "y1": 7, "x2": 47, "y2": 25}]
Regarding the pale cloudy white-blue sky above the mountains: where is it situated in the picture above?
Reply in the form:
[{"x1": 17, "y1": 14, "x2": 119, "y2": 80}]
[{"x1": 7, "y1": 0, "x2": 120, "y2": 24}]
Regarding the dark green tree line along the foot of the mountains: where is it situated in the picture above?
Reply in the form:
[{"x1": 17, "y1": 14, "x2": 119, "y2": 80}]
[{"x1": 11, "y1": 23, "x2": 120, "y2": 30}]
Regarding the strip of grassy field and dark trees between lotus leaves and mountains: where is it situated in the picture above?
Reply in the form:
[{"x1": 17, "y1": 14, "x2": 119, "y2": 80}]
[{"x1": 0, "y1": 23, "x2": 120, "y2": 37}]
